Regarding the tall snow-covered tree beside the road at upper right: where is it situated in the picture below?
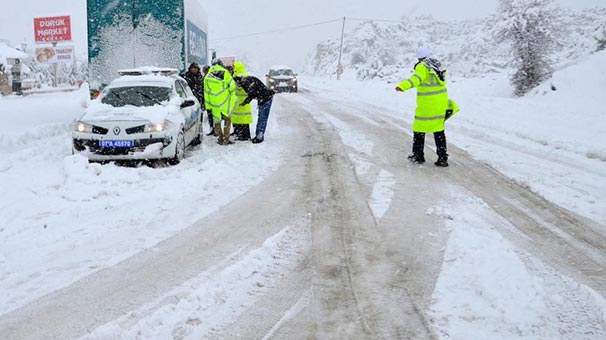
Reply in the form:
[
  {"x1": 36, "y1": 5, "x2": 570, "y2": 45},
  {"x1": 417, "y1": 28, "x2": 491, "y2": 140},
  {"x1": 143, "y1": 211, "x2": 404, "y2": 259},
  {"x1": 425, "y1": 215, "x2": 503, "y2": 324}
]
[{"x1": 494, "y1": 0, "x2": 561, "y2": 96}]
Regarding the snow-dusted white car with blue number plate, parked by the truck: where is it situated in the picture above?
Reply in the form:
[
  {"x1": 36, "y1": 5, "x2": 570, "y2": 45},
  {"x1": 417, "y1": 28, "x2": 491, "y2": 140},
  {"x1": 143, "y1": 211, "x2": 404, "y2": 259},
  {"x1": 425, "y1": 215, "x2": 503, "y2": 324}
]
[{"x1": 72, "y1": 68, "x2": 202, "y2": 164}]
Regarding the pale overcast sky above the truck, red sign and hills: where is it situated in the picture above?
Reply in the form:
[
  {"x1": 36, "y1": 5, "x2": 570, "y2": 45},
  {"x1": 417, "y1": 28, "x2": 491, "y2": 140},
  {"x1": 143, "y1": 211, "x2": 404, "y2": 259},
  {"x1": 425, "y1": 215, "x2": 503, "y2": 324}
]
[{"x1": 0, "y1": 0, "x2": 606, "y2": 67}]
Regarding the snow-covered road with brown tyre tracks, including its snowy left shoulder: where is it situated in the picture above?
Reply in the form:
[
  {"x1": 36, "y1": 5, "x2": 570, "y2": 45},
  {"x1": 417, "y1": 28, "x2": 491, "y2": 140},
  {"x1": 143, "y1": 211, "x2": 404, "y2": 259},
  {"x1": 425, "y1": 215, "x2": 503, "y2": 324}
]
[{"x1": 0, "y1": 75, "x2": 606, "y2": 340}]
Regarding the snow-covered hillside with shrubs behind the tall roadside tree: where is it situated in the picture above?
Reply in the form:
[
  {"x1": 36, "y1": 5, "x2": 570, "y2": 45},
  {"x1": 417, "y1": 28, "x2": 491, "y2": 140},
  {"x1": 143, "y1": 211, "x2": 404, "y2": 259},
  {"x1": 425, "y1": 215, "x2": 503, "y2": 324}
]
[{"x1": 307, "y1": 8, "x2": 606, "y2": 81}]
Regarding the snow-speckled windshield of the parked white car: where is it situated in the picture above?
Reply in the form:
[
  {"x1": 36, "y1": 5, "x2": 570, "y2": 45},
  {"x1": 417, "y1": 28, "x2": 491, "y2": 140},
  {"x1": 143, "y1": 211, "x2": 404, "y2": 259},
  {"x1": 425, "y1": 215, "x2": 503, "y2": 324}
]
[{"x1": 101, "y1": 86, "x2": 170, "y2": 107}]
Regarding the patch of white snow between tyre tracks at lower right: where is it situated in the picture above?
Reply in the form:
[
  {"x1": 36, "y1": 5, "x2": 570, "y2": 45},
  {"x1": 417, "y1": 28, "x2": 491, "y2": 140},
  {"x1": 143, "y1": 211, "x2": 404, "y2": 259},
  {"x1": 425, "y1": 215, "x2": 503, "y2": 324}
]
[{"x1": 428, "y1": 195, "x2": 606, "y2": 340}]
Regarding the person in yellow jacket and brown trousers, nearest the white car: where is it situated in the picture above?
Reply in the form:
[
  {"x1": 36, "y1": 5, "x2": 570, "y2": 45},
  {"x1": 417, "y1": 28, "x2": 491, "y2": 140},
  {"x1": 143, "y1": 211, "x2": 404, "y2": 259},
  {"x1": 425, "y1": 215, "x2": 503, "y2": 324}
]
[{"x1": 204, "y1": 59, "x2": 237, "y2": 145}]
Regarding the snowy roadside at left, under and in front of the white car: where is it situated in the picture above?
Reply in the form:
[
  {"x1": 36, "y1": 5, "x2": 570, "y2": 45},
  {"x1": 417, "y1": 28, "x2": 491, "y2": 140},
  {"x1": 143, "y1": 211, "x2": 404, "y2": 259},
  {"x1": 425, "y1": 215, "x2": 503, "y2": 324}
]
[{"x1": 0, "y1": 92, "x2": 288, "y2": 314}]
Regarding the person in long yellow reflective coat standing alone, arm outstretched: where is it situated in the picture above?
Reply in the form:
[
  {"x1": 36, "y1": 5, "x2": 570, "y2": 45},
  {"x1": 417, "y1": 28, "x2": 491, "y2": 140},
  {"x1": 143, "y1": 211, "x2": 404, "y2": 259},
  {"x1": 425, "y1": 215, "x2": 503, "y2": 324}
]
[{"x1": 396, "y1": 48, "x2": 459, "y2": 167}]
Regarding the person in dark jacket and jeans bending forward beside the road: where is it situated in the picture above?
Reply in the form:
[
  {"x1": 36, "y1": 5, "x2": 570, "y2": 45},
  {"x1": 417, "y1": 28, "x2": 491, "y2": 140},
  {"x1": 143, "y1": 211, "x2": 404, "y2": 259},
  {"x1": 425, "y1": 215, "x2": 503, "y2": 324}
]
[{"x1": 234, "y1": 76, "x2": 275, "y2": 144}]
